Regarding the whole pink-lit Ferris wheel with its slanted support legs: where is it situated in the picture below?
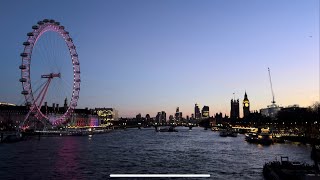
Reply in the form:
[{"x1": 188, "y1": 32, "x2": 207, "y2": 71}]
[{"x1": 19, "y1": 19, "x2": 80, "y2": 127}]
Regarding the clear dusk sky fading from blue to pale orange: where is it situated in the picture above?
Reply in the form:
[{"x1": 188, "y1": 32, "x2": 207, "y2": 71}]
[{"x1": 0, "y1": 0, "x2": 320, "y2": 117}]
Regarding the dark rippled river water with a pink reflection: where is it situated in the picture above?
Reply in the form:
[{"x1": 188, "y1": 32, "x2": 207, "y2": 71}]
[{"x1": 0, "y1": 127, "x2": 312, "y2": 180}]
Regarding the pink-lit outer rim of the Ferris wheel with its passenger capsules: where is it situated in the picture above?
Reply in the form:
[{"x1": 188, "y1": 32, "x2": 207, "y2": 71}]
[{"x1": 19, "y1": 19, "x2": 81, "y2": 124}]
